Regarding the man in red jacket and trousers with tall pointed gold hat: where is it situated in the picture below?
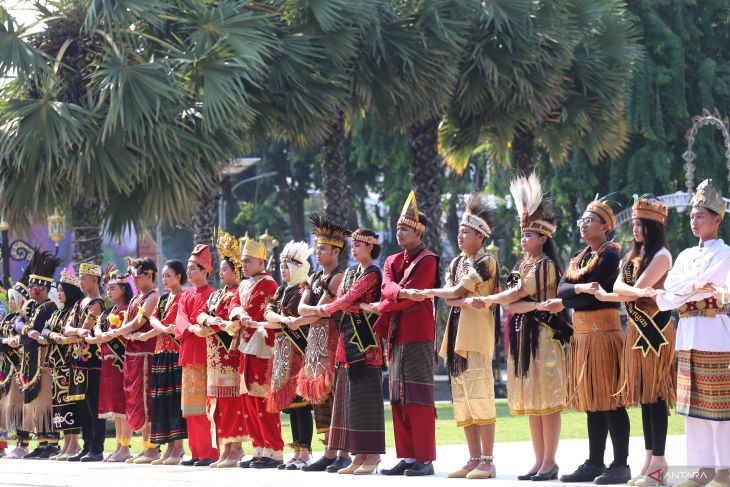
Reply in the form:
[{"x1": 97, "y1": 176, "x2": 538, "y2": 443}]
[{"x1": 368, "y1": 191, "x2": 439, "y2": 476}]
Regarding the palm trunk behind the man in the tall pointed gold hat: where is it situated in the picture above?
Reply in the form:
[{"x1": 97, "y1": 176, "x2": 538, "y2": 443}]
[{"x1": 408, "y1": 117, "x2": 442, "y2": 254}]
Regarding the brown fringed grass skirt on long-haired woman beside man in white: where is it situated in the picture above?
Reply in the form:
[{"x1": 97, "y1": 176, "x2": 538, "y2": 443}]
[{"x1": 621, "y1": 316, "x2": 677, "y2": 413}]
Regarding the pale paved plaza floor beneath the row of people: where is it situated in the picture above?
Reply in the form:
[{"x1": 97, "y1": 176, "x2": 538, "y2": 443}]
[{"x1": 0, "y1": 436, "x2": 685, "y2": 487}]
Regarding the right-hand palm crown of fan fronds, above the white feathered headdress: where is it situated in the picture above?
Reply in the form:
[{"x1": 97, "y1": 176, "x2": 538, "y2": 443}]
[{"x1": 441, "y1": 0, "x2": 640, "y2": 173}]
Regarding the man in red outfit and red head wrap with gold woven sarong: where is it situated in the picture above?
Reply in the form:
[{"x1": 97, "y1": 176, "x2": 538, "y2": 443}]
[{"x1": 175, "y1": 244, "x2": 218, "y2": 467}]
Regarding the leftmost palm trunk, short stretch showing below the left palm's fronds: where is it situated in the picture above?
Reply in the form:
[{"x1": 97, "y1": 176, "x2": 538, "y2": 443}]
[{"x1": 69, "y1": 197, "x2": 104, "y2": 266}]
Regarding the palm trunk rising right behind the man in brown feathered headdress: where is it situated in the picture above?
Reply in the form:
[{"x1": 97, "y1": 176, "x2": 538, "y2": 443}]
[{"x1": 322, "y1": 112, "x2": 357, "y2": 265}]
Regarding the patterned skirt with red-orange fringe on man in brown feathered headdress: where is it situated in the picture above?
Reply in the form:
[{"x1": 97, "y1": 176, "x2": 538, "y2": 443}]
[{"x1": 297, "y1": 319, "x2": 337, "y2": 404}]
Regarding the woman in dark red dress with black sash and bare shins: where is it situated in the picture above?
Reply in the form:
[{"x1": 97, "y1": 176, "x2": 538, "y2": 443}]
[{"x1": 94, "y1": 267, "x2": 134, "y2": 462}]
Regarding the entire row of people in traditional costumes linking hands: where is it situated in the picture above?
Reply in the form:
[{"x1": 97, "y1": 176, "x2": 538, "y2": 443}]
[{"x1": 0, "y1": 174, "x2": 730, "y2": 487}]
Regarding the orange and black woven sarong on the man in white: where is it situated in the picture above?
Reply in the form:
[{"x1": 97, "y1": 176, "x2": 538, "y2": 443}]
[{"x1": 677, "y1": 350, "x2": 730, "y2": 421}]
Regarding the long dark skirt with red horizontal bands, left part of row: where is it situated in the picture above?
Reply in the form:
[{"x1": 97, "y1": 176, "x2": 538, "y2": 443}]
[{"x1": 150, "y1": 350, "x2": 188, "y2": 444}]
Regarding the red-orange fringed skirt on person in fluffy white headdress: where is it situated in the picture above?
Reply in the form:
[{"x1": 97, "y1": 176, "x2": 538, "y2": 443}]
[{"x1": 266, "y1": 335, "x2": 308, "y2": 413}]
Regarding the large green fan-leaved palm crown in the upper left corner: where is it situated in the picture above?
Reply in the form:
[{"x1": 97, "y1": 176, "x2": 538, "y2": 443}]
[{"x1": 0, "y1": 0, "x2": 280, "y2": 262}]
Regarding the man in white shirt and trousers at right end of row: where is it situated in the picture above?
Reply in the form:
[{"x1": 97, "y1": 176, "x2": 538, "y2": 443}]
[{"x1": 656, "y1": 179, "x2": 730, "y2": 487}]
